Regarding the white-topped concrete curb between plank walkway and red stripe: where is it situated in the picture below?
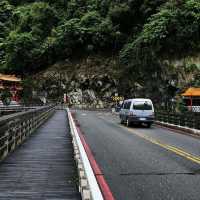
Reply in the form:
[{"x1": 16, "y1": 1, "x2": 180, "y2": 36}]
[{"x1": 66, "y1": 109, "x2": 103, "y2": 200}]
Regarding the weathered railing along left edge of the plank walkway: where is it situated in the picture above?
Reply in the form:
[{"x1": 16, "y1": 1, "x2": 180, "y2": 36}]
[{"x1": 0, "y1": 106, "x2": 55, "y2": 160}]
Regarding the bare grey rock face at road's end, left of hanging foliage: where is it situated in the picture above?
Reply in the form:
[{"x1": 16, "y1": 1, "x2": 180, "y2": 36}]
[{"x1": 36, "y1": 56, "x2": 119, "y2": 108}]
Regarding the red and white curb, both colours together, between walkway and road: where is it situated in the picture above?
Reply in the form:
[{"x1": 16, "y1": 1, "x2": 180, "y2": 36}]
[{"x1": 67, "y1": 109, "x2": 114, "y2": 200}]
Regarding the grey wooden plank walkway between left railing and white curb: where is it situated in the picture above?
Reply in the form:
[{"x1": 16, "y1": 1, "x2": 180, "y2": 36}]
[{"x1": 0, "y1": 111, "x2": 80, "y2": 200}]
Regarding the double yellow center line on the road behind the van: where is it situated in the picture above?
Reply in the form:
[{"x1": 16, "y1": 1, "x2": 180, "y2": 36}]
[{"x1": 122, "y1": 126, "x2": 200, "y2": 164}]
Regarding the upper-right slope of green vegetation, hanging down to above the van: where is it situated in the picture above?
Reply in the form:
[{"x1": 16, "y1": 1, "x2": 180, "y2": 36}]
[{"x1": 120, "y1": 0, "x2": 200, "y2": 91}]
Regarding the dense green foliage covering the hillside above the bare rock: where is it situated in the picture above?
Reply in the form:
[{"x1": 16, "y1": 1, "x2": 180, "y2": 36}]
[{"x1": 0, "y1": 0, "x2": 200, "y2": 90}]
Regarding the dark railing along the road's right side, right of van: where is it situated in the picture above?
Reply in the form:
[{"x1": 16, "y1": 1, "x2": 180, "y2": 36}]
[{"x1": 156, "y1": 110, "x2": 200, "y2": 130}]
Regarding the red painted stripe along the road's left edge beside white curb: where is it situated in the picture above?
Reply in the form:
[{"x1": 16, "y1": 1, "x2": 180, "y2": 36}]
[{"x1": 73, "y1": 116, "x2": 115, "y2": 200}]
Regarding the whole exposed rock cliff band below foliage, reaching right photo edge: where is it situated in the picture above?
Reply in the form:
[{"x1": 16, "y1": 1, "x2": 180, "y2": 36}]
[{"x1": 34, "y1": 55, "x2": 200, "y2": 108}]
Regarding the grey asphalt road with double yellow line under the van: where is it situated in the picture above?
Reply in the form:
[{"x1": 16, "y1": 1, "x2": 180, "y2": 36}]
[{"x1": 76, "y1": 111, "x2": 200, "y2": 200}]
